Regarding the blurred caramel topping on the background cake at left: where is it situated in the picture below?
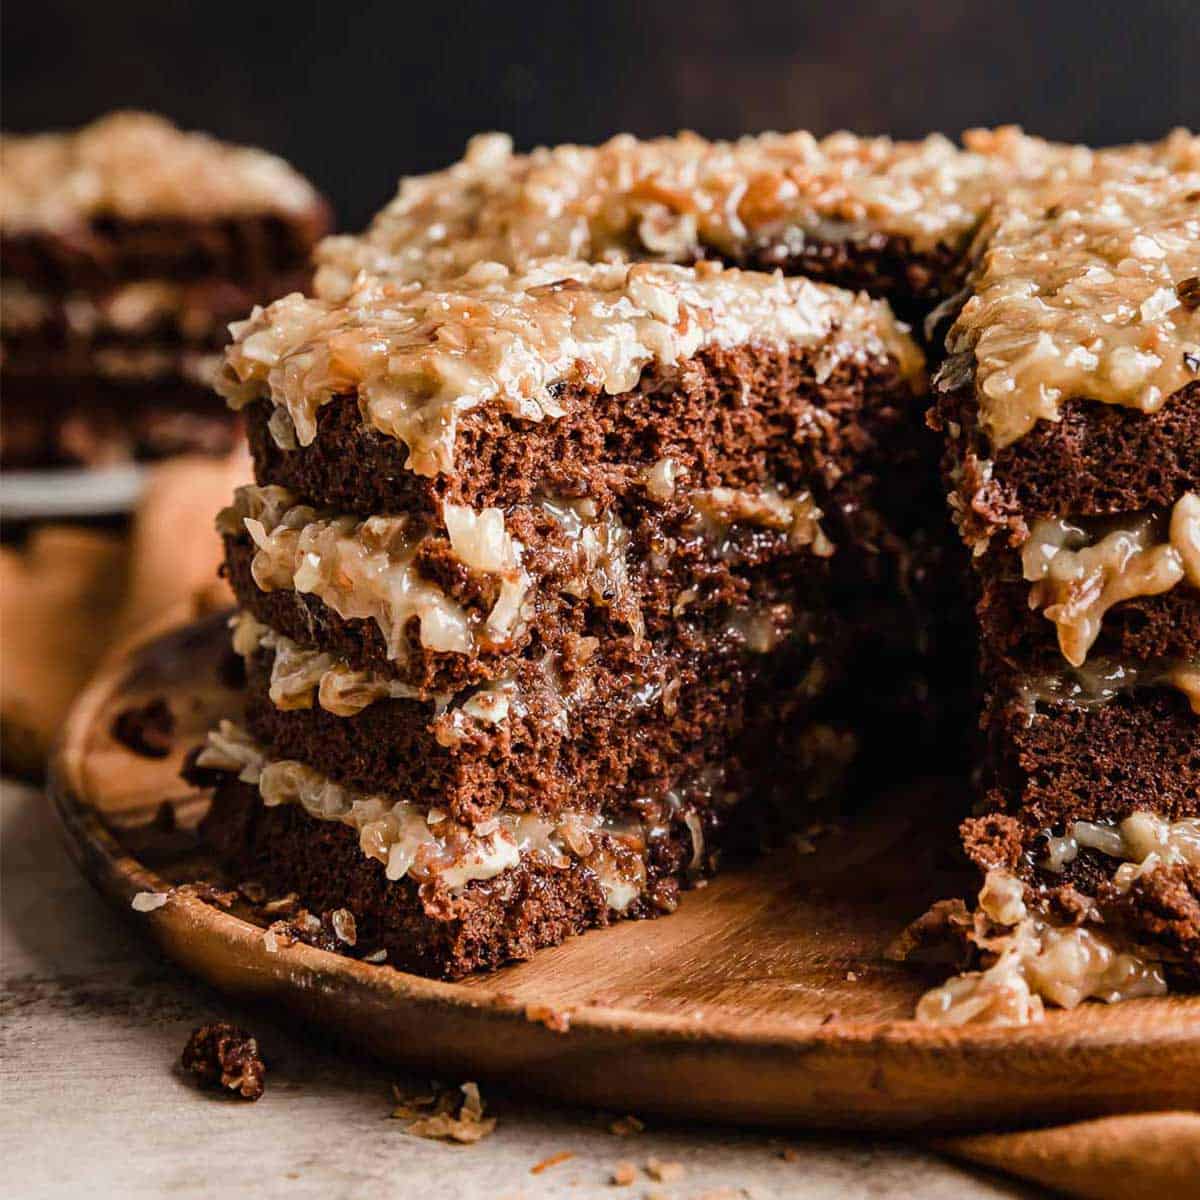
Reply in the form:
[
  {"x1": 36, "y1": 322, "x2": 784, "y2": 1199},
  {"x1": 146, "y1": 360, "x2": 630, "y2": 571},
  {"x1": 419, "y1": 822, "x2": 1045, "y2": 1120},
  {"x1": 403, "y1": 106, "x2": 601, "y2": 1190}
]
[{"x1": 0, "y1": 113, "x2": 318, "y2": 233}]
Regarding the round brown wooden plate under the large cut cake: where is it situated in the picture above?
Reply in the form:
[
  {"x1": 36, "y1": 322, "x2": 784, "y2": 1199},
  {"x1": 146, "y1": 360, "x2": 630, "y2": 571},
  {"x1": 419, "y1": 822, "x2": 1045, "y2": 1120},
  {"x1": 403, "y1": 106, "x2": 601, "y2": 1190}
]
[{"x1": 52, "y1": 616, "x2": 1200, "y2": 1130}]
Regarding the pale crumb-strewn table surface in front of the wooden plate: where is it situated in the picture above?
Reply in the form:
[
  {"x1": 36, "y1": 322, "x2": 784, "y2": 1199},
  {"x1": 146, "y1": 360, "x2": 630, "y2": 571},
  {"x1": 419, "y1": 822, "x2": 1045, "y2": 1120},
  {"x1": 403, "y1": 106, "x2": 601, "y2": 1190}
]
[{"x1": 0, "y1": 781, "x2": 1030, "y2": 1200}]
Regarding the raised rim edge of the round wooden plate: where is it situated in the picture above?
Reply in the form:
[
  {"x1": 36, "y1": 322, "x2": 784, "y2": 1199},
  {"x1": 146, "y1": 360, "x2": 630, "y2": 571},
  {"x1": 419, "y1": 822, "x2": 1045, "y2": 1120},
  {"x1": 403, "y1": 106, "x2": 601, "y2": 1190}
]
[{"x1": 49, "y1": 612, "x2": 1200, "y2": 1127}]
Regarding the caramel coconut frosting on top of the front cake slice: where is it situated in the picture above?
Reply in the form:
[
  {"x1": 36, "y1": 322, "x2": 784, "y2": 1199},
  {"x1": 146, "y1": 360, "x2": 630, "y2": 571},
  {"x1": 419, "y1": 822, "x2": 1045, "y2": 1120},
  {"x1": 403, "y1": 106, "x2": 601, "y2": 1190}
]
[{"x1": 218, "y1": 262, "x2": 922, "y2": 475}]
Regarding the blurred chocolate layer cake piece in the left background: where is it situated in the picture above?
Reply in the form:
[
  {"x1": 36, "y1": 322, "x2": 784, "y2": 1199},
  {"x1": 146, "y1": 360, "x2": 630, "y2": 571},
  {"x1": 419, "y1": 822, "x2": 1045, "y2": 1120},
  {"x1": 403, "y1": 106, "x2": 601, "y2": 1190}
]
[{"x1": 0, "y1": 113, "x2": 329, "y2": 468}]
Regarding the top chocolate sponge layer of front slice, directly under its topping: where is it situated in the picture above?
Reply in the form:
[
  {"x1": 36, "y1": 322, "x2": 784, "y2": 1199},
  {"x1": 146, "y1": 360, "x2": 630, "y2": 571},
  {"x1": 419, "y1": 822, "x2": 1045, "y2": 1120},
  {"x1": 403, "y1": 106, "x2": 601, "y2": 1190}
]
[{"x1": 238, "y1": 346, "x2": 934, "y2": 514}]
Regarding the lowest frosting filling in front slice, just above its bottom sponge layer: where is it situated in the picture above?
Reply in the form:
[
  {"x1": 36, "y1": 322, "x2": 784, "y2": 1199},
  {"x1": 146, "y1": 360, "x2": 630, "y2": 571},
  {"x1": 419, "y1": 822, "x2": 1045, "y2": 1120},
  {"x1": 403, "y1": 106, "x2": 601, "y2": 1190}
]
[{"x1": 197, "y1": 721, "x2": 704, "y2": 912}]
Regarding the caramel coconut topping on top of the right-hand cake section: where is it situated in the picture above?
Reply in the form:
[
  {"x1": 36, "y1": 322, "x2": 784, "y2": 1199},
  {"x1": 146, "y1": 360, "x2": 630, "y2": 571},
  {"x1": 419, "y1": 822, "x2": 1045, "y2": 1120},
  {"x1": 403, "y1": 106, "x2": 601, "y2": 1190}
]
[{"x1": 947, "y1": 132, "x2": 1200, "y2": 449}]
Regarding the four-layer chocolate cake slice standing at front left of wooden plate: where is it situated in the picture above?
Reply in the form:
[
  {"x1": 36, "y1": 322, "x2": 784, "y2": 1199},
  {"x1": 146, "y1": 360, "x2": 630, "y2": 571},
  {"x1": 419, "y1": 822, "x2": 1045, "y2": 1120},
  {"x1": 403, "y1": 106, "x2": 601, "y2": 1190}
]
[{"x1": 196, "y1": 255, "x2": 923, "y2": 976}]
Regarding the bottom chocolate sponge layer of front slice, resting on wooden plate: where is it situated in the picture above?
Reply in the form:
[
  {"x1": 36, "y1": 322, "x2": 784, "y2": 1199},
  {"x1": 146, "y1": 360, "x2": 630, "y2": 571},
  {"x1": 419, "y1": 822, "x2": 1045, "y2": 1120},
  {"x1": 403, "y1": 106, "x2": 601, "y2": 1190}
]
[{"x1": 203, "y1": 779, "x2": 716, "y2": 979}]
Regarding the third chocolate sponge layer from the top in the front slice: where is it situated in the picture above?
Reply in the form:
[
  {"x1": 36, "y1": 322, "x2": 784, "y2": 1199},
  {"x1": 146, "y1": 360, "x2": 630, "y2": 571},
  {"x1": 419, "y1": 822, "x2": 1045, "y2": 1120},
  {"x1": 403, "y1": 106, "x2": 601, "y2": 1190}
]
[{"x1": 238, "y1": 609, "x2": 834, "y2": 822}]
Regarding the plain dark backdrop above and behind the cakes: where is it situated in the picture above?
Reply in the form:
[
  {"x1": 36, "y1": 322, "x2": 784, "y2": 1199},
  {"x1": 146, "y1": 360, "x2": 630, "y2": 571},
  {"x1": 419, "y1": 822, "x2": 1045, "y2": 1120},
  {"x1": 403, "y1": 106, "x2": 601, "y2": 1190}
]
[{"x1": 2, "y1": 0, "x2": 1200, "y2": 228}]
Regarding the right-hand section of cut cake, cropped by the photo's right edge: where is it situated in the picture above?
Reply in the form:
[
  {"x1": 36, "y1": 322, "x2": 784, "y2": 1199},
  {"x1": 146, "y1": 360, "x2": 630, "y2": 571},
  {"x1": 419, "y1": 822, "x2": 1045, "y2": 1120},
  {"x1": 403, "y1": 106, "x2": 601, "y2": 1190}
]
[{"x1": 935, "y1": 147, "x2": 1200, "y2": 998}]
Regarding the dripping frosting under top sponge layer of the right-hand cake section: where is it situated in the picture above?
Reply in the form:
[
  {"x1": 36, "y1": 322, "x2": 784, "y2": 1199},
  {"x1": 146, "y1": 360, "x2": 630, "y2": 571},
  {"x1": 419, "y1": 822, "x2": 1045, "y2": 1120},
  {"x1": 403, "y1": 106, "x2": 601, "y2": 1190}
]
[{"x1": 1021, "y1": 492, "x2": 1200, "y2": 667}]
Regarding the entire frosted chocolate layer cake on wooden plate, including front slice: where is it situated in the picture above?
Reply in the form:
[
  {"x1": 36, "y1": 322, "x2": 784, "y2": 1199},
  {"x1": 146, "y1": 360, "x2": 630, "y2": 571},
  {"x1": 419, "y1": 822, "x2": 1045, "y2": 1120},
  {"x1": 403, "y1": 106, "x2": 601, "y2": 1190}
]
[{"x1": 192, "y1": 130, "x2": 1200, "y2": 1020}]
